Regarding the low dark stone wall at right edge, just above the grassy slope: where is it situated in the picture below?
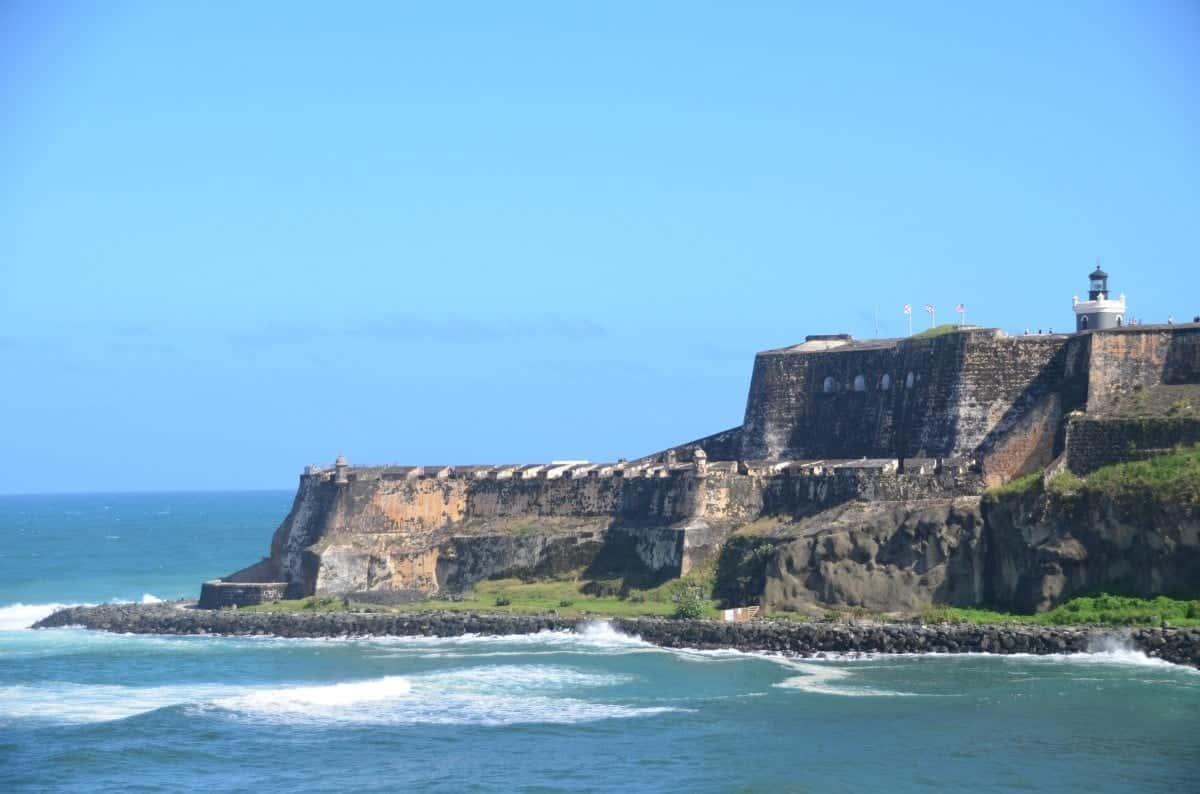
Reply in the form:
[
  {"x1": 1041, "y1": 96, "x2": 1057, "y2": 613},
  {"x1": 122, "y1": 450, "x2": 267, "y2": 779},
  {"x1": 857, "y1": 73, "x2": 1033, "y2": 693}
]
[{"x1": 1067, "y1": 416, "x2": 1200, "y2": 474}]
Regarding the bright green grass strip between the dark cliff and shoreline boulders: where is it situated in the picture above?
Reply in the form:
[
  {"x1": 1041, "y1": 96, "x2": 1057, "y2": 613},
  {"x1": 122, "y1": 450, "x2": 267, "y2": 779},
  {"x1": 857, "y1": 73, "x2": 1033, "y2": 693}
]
[{"x1": 922, "y1": 594, "x2": 1200, "y2": 626}]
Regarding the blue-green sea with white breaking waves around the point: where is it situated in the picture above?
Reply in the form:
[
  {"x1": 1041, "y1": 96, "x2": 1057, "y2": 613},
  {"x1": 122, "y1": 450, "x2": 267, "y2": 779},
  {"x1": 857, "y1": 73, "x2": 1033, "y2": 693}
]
[{"x1": 0, "y1": 492, "x2": 1200, "y2": 792}]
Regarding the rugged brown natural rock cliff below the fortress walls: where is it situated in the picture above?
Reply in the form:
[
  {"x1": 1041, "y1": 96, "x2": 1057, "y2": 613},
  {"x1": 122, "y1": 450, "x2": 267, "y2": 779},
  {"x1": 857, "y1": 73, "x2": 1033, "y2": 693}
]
[{"x1": 762, "y1": 489, "x2": 1200, "y2": 613}]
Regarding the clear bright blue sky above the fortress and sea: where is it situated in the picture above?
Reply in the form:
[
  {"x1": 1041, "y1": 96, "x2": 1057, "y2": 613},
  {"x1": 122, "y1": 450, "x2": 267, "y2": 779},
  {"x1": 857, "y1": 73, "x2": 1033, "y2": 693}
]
[{"x1": 0, "y1": 0, "x2": 1200, "y2": 493}]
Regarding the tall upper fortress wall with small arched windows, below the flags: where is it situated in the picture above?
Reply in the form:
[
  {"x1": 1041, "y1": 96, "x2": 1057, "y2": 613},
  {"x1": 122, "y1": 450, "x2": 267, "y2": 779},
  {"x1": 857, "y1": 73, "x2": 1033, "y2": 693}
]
[{"x1": 742, "y1": 331, "x2": 1086, "y2": 481}]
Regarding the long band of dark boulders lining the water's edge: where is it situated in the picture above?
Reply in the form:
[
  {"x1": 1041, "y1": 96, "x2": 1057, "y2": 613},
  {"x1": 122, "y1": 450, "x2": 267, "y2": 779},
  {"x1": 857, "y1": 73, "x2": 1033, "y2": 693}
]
[{"x1": 34, "y1": 603, "x2": 1200, "y2": 668}]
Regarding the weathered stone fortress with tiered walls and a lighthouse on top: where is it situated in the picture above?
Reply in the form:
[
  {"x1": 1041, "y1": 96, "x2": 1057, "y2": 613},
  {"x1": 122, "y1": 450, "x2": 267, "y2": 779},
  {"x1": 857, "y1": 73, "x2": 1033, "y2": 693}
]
[{"x1": 200, "y1": 269, "x2": 1200, "y2": 608}]
